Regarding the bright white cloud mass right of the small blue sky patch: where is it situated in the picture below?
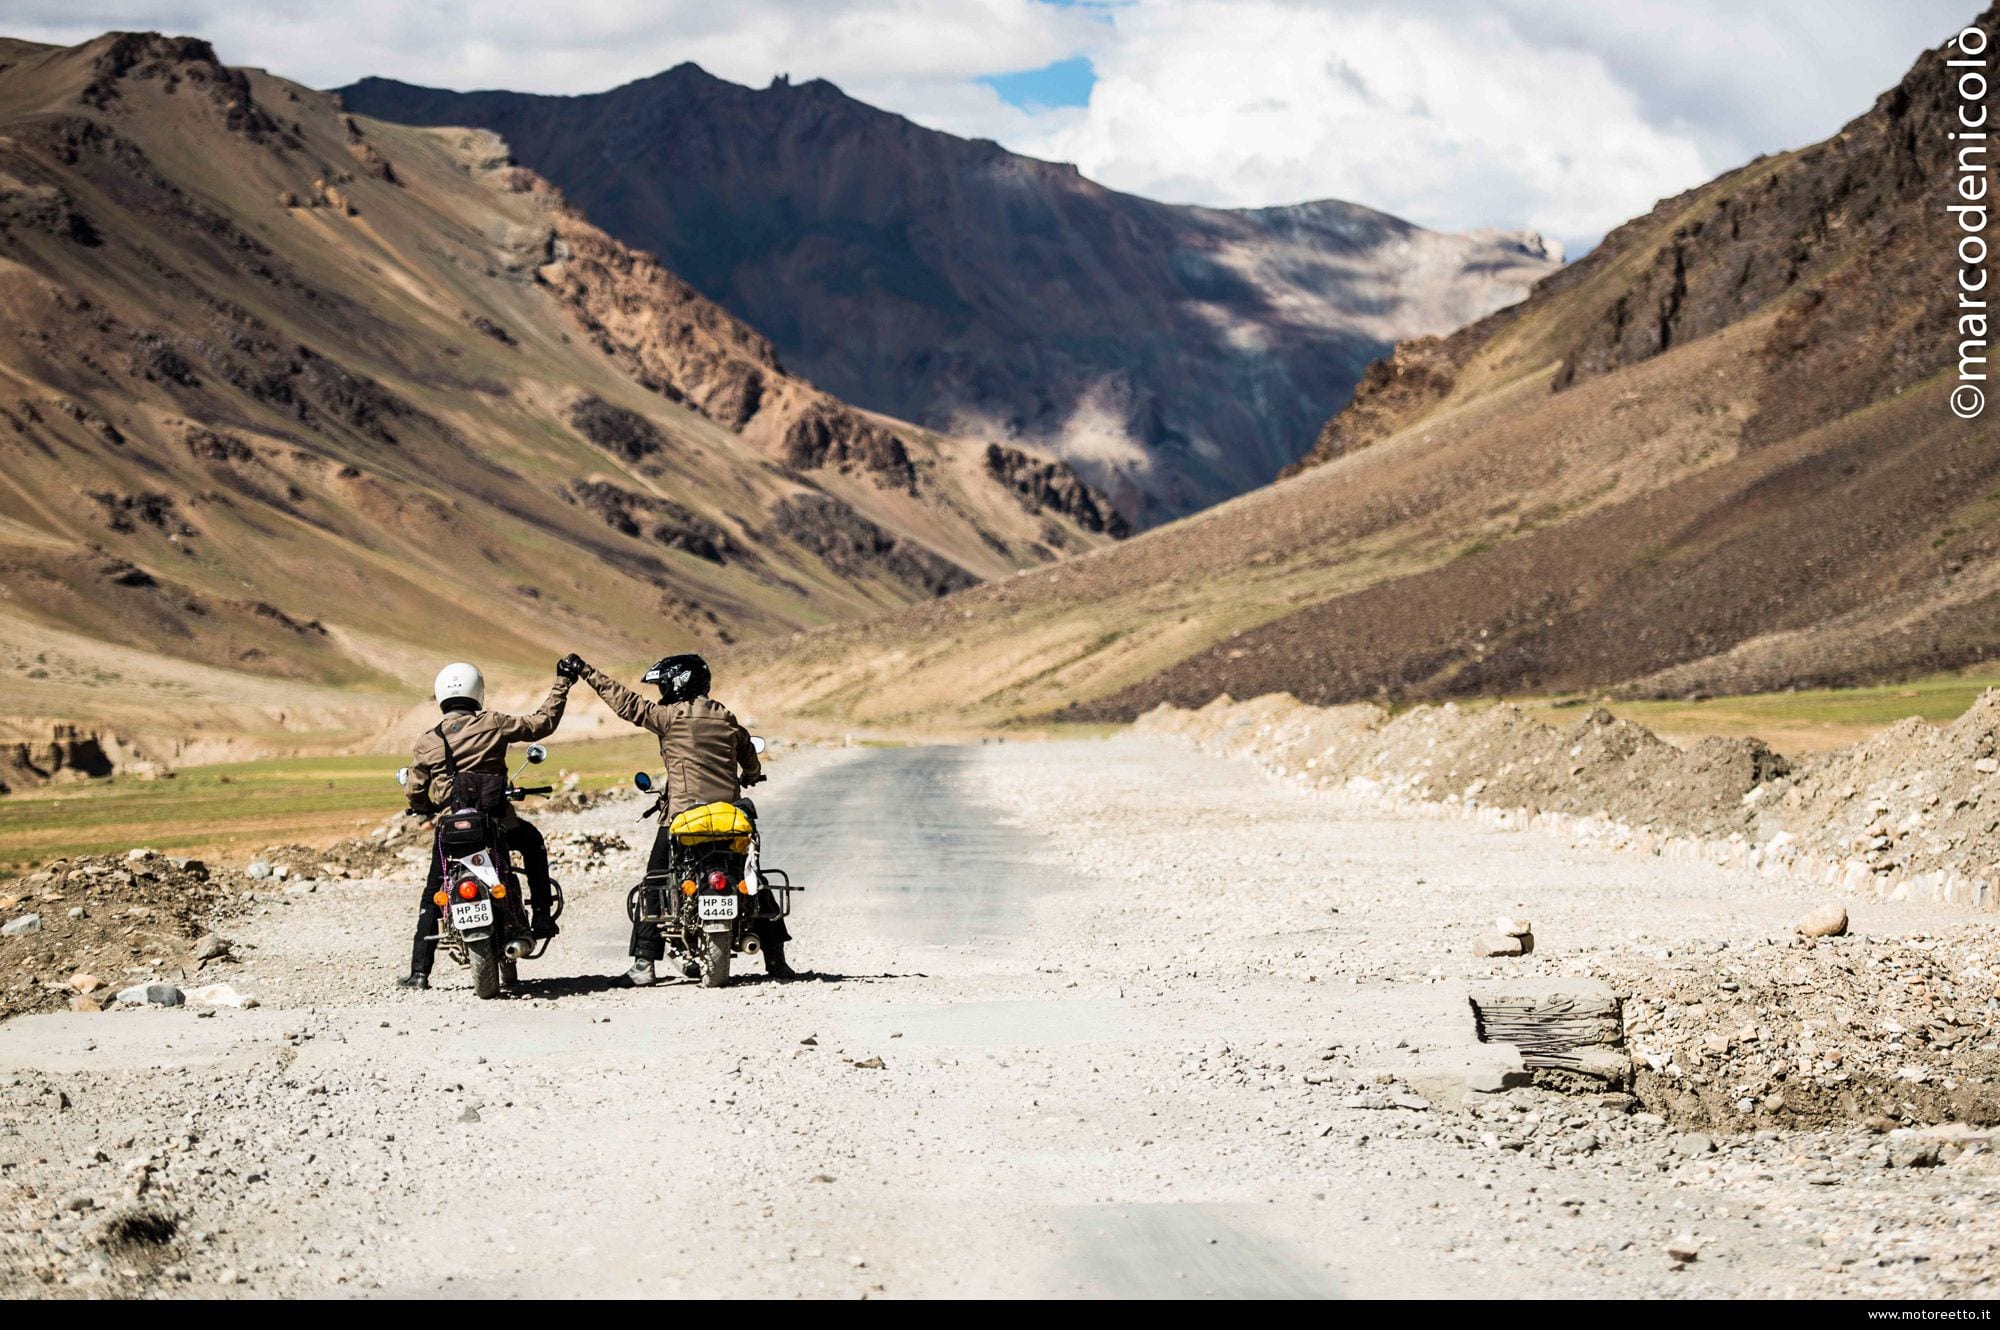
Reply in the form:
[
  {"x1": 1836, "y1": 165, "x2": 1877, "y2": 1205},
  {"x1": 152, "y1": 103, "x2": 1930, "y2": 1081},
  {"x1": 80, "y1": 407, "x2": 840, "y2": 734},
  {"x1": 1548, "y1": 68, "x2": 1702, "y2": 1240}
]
[{"x1": 1014, "y1": 0, "x2": 1968, "y2": 250}]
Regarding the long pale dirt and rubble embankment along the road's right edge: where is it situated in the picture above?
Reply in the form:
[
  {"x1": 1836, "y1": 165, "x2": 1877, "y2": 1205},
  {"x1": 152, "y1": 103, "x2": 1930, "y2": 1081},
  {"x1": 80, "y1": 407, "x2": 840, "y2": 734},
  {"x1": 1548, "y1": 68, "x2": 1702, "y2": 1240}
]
[{"x1": 1138, "y1": 690, "x2": 2000, "y2": 910}]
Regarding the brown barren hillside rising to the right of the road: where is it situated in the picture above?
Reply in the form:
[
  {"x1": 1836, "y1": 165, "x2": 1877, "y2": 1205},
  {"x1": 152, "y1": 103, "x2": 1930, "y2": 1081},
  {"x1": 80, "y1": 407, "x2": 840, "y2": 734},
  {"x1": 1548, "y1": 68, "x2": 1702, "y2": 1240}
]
[{"x1": 740, "y1": 10, "x2": 2000, "y2": 722}]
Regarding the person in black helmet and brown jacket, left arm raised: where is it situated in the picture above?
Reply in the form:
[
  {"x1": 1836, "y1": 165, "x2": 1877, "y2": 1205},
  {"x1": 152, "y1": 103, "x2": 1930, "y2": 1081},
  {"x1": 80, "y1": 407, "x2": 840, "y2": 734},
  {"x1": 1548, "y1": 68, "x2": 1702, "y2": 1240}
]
[{"x1": 560, "y1": 654, "x2": 794, "y2": 986}]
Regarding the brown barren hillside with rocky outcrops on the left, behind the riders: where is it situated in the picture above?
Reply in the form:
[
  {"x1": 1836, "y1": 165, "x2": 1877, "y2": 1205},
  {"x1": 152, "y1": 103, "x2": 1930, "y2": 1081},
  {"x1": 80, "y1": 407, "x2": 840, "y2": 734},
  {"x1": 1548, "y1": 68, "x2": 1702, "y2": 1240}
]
[{"x1": 0, "y1": 34, "x2": 1114, "y2": 756}]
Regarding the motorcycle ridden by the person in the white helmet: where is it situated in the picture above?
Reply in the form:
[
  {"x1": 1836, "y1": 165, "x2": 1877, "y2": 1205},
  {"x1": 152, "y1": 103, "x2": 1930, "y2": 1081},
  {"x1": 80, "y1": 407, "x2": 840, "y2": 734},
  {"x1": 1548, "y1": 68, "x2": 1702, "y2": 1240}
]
[{"x1": 396, "y1": 744, "x2": 562, "y2": 998}]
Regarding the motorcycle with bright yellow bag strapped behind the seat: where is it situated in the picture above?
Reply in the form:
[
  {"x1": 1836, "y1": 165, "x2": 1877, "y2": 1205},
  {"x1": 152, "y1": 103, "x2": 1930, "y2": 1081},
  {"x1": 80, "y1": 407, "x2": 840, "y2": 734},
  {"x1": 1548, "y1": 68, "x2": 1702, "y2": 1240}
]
[{"x1": 626, "y1": 738, "x2": 802, "y2": 988}]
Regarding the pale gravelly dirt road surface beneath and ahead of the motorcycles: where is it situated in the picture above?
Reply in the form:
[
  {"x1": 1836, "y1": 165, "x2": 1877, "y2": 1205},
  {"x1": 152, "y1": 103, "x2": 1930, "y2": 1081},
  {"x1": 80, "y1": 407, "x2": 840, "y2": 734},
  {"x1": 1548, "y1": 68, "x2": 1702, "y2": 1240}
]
[{"x1": 0, "y1": 736, "x2": 2000, "y2": 1298}]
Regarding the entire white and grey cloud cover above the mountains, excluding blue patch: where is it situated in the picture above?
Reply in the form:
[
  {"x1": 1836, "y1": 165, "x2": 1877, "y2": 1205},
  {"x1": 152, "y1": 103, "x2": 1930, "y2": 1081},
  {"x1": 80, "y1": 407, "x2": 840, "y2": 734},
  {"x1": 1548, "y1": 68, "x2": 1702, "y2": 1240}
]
[{"x1": 0, "y1": 0, "x2": 1978, "y2": 248}]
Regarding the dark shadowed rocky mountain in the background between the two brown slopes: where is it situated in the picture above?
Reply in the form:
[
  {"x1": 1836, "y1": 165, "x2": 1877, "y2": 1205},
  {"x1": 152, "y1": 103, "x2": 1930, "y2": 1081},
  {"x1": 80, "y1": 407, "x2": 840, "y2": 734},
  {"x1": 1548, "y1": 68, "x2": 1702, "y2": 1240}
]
[{"x1": 340, "y1": 64, "x2": 1556, "y2": 524}]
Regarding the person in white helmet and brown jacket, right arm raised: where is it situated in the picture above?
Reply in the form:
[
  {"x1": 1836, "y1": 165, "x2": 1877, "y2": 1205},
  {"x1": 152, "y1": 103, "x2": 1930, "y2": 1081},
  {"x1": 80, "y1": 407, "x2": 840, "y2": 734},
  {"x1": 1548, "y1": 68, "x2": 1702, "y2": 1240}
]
[{"x1": 396, "y1": 664, "x2": 576, "y2": 988}]
